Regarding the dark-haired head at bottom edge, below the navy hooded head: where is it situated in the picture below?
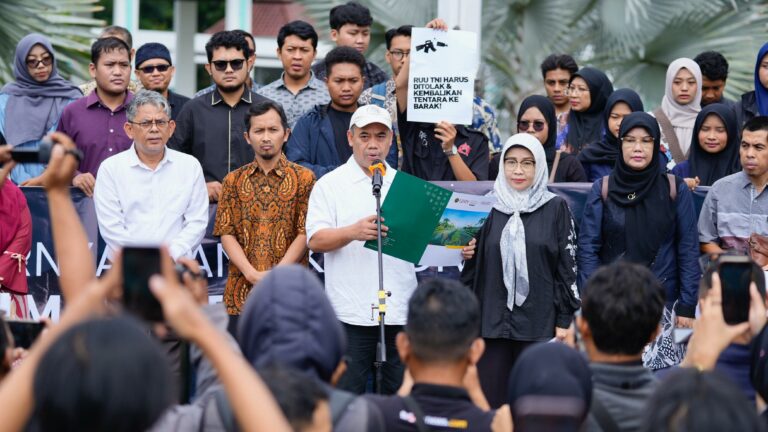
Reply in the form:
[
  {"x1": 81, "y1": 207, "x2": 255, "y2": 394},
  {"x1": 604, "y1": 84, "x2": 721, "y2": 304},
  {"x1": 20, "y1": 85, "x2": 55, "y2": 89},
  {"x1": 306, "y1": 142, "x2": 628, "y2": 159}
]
[{"x1": 259, "y1": 365, "x2": 332, "y2": 432}]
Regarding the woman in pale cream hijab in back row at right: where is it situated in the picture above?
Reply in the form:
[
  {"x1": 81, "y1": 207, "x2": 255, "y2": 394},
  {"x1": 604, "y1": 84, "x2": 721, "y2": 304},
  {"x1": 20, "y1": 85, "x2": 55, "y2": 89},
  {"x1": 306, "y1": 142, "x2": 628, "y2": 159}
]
[{"x1": 651, "y1": 57, "x2": 702, "y2": 169}]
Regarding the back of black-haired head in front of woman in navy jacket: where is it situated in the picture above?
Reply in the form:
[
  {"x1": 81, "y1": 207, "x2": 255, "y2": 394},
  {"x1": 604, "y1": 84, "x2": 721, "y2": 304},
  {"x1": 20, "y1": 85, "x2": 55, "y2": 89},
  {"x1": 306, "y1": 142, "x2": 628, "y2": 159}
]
[{"x1": 578, "y1": 261, "x2": 665, "y2": 360}]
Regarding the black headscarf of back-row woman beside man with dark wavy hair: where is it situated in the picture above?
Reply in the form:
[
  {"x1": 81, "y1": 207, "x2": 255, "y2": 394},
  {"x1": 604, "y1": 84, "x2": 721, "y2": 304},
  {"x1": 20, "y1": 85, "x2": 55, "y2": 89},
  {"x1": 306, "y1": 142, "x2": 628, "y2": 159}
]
[{"x1": 565, "y1": 67, "x2": 613, "y2": 153}]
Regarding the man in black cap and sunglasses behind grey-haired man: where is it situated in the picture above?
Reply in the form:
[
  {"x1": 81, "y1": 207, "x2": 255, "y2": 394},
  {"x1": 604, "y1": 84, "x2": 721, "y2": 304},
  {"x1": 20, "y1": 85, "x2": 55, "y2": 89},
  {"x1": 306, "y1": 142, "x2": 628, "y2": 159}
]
[{"x1": 134, "y1": 42, "x2": 189, "y2": 121}]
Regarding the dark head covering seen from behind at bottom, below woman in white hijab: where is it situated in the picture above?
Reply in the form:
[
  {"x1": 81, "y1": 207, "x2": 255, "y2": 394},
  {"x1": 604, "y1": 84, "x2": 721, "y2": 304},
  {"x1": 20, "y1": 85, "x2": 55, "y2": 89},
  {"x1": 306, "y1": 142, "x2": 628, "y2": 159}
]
[{"x1": 507, "y1": 343, "x2": 592, "y2": 432}]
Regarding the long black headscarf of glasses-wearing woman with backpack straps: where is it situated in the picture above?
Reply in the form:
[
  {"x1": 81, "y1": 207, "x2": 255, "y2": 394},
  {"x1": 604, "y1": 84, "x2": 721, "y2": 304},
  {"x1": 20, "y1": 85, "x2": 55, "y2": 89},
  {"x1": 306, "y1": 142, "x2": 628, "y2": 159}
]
[{"x1": 608, "y1": 112, "x2": 675, "y2": 266}]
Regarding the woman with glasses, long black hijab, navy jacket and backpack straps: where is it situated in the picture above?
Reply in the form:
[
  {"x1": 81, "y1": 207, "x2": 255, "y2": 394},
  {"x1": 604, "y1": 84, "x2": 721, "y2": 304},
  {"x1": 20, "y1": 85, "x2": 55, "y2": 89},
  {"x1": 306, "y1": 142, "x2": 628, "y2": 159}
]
[{"x1": 578, "y1": 112, "x2": 701, "y2": 369}]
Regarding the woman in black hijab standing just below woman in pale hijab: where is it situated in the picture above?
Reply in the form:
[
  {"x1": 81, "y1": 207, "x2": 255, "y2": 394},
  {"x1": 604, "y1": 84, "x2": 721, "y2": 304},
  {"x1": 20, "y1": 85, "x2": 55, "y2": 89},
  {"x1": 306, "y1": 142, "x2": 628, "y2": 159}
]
[{"x1": 672, "y1": 103, "x2": 741, "y2": 190}]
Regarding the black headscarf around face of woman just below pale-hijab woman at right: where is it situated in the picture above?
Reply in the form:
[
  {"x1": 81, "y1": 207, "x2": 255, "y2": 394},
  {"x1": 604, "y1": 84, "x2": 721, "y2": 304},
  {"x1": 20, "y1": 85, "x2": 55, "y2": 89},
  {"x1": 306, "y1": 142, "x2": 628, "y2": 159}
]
[{"x1": 688, "y1": 103, "x2": 741, "y2": 186}]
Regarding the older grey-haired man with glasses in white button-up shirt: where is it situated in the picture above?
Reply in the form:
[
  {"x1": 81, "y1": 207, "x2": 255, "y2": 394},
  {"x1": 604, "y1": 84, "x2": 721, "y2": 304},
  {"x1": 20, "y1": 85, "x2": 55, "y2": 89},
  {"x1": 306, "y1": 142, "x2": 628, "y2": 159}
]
[{"x1": 94, "y1": 90, "x2": 208, "y2": 259}]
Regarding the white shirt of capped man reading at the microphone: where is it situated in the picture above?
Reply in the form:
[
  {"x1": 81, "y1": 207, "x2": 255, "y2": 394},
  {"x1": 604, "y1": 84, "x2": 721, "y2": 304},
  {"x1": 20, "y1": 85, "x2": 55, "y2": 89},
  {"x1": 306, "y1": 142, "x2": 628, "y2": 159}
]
[{"x1": 307, "y1": 156, "x2": 417, "y2": 326}]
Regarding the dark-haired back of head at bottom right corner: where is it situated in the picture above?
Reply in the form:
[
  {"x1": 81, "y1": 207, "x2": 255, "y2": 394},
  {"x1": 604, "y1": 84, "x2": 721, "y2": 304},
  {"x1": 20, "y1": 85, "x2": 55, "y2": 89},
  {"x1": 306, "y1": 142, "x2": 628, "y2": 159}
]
[{"x1": 641, "y1": 368, "x2": 765, "y2": 432}]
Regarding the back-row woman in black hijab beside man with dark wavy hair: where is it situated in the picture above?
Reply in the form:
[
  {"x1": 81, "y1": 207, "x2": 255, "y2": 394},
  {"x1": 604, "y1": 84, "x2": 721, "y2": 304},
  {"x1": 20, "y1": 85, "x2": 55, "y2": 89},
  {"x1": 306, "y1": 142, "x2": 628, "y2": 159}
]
[{"x1": 565, "y1": 67, "x2": 613, "y2": 154}]
